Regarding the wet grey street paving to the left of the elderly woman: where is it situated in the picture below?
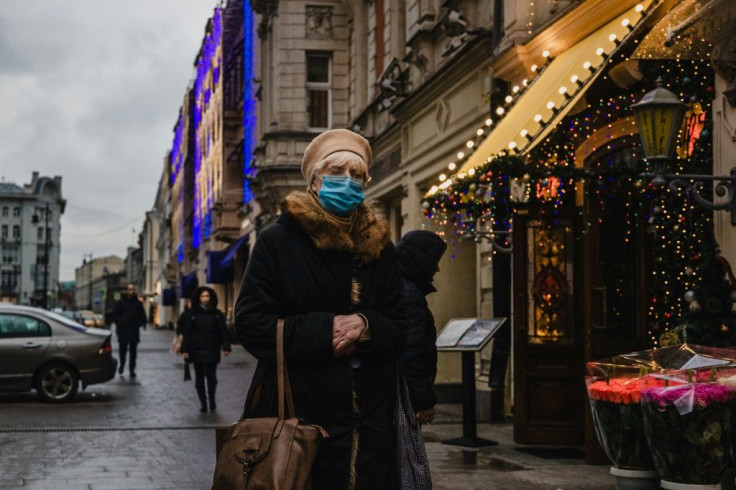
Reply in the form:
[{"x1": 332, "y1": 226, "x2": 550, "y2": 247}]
[{"x1": 0, "y1": 328, "x2": 255, "y2": 490}]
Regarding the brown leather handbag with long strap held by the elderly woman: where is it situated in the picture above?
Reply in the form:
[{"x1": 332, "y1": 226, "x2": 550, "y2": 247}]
[{"x1": 212, "y1": 319, "x2": 328, "y2": 490}]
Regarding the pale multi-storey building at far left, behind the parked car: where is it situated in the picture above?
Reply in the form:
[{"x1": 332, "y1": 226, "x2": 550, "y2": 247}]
[{"x1": 0, "y1": 172, "x2": 66, "y2": 308}]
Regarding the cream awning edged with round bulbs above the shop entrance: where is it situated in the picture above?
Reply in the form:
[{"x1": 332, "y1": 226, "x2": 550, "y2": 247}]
[{"x1": 458, "y1": 1, "x2": 653, "y2": 176}]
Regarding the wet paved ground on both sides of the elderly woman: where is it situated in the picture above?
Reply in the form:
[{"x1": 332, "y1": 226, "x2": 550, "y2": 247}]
[{"x1": 0, "y1": 328, "x2": 614, "y2": 490}]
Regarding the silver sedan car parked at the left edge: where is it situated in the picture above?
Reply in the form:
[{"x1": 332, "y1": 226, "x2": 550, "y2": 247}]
[{"x1": 0, "y1": 303, "x2": 118, "y2": 402}]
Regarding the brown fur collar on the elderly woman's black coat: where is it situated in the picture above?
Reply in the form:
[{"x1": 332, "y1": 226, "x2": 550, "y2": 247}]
[{"x1": 282, "y1": 191, "x2": 391, "y2": 262}]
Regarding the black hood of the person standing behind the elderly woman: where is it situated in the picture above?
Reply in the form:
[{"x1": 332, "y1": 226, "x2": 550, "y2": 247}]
[{"x1": 396, "y1": 230, "x2": 447, "y2": 294}]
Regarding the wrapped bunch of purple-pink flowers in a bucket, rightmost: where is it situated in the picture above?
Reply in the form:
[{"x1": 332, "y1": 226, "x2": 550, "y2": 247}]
[{"x1": 641, "y1": 375, "x2": 736, "y2": 485}]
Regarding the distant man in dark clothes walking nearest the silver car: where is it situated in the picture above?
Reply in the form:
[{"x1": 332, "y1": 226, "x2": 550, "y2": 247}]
[{"x1": 112, "y1": 284, "x2": 147, "y2": 378}]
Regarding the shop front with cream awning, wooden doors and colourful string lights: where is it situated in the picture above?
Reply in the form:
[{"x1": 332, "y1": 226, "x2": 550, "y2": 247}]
[{"x1": 423, "y1": 1, "x2": 736, "y2": 460}]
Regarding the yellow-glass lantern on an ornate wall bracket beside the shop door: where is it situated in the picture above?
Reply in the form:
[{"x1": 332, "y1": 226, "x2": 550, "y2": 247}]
[{"x1": 631, "y1": 78, "x2": 736, "y2": 226}]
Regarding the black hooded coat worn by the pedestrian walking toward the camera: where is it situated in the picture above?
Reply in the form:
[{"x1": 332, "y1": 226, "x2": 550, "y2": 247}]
[{"x1": 181, "y1": 287, "x2": 230, "y2": 364}]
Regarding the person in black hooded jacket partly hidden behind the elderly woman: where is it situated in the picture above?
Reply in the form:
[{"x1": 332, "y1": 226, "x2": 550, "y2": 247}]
[{"x1": 396, "y1": 230, "x2": 447, "y2": 424}]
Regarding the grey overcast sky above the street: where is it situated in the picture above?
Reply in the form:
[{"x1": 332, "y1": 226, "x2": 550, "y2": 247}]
[{"x1": 0, "y1": 0, "x2": 218, "y2": 281}]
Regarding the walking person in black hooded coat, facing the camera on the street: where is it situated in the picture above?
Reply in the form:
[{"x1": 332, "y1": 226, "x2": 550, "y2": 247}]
[{"x1": 181, "y1": 287, "x2": 230, "y2": 412}]
